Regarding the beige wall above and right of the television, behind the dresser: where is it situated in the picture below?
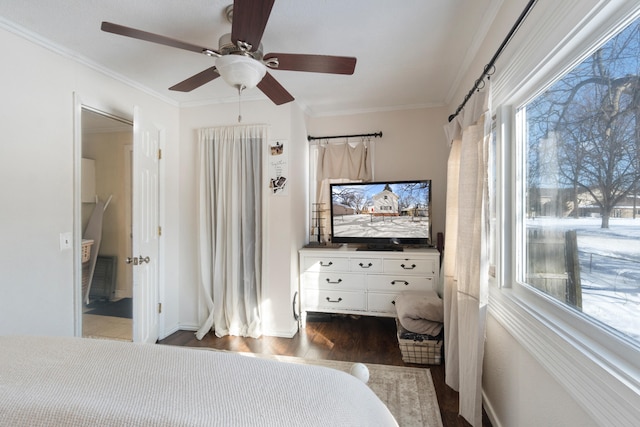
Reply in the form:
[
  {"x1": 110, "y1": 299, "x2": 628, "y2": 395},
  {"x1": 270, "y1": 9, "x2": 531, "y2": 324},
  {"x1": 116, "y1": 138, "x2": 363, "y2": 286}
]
[{"x1": 307, "y1": 108, "x2": 450, "y2": 241}]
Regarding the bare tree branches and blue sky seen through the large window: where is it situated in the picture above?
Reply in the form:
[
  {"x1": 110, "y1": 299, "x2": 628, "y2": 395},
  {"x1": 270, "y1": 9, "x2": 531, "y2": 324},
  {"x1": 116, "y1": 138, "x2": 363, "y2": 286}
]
[{"x1": 527, "y1": 23, "x2": 640, "y2": 228}]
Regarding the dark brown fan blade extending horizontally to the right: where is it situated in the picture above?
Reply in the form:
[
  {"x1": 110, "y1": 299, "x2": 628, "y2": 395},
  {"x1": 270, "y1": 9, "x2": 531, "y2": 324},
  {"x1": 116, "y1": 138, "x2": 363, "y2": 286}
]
[{"x1": 264, "y1": 53, "x2": 356, "y2": 74}]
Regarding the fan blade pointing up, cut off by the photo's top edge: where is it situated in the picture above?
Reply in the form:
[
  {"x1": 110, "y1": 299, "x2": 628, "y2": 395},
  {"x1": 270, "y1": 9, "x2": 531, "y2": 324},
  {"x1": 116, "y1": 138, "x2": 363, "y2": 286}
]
[{"x1": 231, "y1": 0, "x2": 275, "y2": 52}]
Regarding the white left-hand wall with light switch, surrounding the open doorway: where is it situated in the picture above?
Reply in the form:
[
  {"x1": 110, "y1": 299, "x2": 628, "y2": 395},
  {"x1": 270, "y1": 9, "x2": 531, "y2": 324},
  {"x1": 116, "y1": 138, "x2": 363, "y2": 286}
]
[{"x1": 0, "y1": 28, "x2": 179, "y2": 335}]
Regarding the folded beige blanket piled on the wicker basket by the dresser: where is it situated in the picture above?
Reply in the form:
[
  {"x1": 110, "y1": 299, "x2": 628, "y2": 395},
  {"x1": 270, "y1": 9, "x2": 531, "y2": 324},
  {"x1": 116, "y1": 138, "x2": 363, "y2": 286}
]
[{"x1": 395, "y1": 291, "x2": 444, "y2": 336}]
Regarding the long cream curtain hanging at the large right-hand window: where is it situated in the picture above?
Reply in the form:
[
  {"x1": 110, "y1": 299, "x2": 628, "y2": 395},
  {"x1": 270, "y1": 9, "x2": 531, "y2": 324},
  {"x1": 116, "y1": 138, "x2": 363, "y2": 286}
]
[{"x1": 443, "y1": 92, "x2": 491, "y2": 426}]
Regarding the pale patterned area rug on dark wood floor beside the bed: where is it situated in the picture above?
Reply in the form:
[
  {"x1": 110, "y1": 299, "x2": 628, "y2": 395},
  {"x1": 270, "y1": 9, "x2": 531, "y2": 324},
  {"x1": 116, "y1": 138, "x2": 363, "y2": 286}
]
[{"x1": 232, "y1": 353, "x2": 442, "y2": 427}]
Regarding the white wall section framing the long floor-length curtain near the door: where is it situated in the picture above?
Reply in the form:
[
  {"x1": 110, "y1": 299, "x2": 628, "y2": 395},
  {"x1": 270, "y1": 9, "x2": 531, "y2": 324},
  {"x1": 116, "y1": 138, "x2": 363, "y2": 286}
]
[{"x1": 174, "y1": 99, "x2": 307, "y2": 336}]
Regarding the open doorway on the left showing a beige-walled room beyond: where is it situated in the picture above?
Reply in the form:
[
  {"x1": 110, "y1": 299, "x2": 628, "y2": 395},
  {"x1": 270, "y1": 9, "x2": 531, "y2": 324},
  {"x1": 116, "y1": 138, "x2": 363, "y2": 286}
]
[{"x1": 81, "y1": 107, "x2": 133, "y2": 341}]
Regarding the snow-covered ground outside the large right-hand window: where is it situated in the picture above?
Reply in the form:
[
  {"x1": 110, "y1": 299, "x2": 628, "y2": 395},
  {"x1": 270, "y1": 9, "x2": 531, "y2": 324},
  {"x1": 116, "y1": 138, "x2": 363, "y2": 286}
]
[{"x1": 527, "y1": 218, "x2": 640, "y2": 341}]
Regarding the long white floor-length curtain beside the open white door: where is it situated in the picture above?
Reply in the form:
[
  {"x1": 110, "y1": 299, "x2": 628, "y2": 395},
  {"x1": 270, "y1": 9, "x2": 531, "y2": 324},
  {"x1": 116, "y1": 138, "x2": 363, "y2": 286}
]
[{"x1": 196, "y1": 126, "x2": 267, "y2": 339}]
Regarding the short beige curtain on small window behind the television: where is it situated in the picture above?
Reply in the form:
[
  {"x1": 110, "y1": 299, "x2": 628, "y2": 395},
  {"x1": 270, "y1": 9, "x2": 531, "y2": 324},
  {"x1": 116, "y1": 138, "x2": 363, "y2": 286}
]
[{"x1": 316, "y1": 142, "x2": 373, "y2": 242}]
